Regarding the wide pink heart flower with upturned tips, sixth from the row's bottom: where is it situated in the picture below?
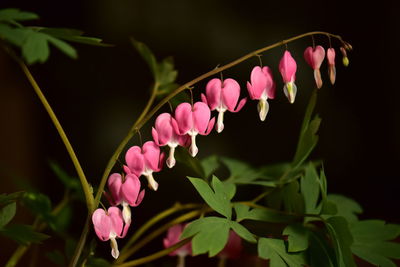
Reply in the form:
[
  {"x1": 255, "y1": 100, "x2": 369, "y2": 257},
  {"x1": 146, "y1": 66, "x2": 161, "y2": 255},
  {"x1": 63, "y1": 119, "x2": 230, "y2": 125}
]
[{"x1": 201, "y1": 78, "x2": 247, "y2": 133}]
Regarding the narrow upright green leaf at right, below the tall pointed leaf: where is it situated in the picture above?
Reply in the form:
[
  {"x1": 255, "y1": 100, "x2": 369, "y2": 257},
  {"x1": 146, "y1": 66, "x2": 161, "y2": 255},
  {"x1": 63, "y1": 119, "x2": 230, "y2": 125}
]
[{"x1": 301, "y1": 163, "x2": 320, "y2": 214}]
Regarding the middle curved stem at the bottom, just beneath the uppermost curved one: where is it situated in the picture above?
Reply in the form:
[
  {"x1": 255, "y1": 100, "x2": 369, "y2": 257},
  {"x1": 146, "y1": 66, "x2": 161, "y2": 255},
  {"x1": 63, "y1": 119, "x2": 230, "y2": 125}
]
[{"x1": 116, "y1": 210, "x2": 204, "y2": 263}]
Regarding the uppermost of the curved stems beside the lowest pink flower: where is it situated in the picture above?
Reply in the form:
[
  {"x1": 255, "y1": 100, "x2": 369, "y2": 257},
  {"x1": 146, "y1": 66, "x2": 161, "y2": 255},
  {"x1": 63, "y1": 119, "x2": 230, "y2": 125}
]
[{"x1": 120, "y1": 203, "x2": 203, "y2": 255}]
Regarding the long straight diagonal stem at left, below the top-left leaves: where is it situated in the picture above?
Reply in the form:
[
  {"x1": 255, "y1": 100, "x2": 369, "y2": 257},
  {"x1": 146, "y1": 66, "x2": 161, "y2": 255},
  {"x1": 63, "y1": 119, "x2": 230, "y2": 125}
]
[{"x1": 17, "y1": 59, "x2": 94, "y2": 212}]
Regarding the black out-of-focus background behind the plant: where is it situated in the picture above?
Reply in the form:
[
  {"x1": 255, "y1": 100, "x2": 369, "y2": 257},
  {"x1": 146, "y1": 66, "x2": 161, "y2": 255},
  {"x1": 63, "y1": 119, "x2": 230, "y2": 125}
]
[{"x1": 0, "y1": 0, "x2": 400, "y2": 266}]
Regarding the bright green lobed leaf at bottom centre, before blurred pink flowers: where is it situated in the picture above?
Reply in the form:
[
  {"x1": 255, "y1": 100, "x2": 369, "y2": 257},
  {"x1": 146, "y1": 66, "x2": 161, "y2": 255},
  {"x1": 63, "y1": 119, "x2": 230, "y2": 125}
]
[{"x1": 181, "y1": 217, "x2": 230, "y2": 257}]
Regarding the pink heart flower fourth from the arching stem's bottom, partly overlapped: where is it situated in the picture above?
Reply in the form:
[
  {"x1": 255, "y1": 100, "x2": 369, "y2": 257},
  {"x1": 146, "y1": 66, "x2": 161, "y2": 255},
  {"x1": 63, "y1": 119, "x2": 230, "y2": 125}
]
[{"x1": 152, "y1": 113, "x2": 190, "y2": 168}]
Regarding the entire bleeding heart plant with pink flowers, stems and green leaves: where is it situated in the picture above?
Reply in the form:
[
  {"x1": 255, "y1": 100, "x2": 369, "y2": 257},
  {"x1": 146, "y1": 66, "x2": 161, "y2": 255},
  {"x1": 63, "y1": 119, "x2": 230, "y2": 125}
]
[{"x1": 0, "y1": 9, "x2": 400, "y2": 267}]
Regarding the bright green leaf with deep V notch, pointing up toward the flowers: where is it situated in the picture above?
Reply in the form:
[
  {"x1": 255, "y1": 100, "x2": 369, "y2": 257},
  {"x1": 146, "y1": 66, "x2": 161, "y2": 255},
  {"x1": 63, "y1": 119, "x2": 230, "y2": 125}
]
[{"x1": 188, "y1": 176, "x2": 232, "y2": 219}]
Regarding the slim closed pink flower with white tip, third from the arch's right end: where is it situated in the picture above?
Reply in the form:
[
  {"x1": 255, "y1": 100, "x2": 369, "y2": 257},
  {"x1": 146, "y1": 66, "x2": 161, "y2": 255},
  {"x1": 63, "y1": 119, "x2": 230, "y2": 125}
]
[{"x1": 279, "y1": 50, "x2": 297, "y2": 103}]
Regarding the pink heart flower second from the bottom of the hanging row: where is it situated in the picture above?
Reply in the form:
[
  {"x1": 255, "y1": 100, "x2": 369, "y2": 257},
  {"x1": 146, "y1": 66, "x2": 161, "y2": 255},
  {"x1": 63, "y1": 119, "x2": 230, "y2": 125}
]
[{"x1": 108, "y1": 173, "x2": 145, "y2": 225}]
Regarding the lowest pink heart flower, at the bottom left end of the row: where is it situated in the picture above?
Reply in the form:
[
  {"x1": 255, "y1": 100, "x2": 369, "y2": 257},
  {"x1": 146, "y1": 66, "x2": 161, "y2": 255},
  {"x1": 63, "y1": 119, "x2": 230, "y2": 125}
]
[{"x1": 92, "y1": 207, "x2": 129, "y2": 259}]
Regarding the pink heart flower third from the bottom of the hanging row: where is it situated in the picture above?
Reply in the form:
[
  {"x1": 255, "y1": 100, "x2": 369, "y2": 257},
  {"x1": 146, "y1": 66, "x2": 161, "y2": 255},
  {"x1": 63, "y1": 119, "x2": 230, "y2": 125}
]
[{"x1": 124, "y1": 141, "x2": 165, "y2": 191}]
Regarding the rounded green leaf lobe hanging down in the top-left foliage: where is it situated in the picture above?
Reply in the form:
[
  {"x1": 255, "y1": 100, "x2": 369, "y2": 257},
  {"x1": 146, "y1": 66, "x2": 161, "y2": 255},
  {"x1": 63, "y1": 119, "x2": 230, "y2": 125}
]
[{"x1": 22, "y1": 30, "x2": 50, "y2": 64}]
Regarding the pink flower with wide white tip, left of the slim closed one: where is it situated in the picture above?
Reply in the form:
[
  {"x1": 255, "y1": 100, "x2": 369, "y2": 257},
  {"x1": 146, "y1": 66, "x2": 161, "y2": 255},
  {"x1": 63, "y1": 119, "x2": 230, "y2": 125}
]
[{"x1": 247, "y1": 66, "x2": 276, "y2": 121}]
